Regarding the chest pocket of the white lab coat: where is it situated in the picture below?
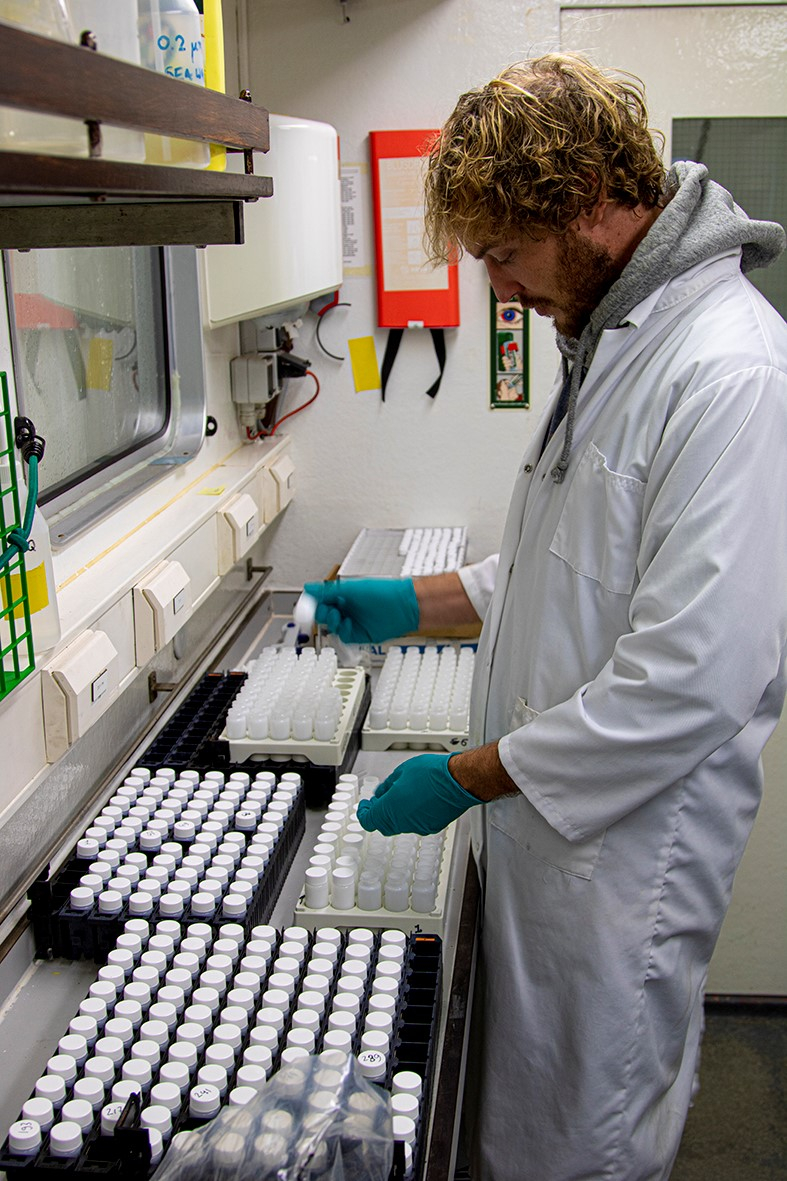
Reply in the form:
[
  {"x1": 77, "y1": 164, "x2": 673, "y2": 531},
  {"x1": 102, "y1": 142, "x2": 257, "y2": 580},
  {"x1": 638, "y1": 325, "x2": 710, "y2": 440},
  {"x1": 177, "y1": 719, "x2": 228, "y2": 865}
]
[{"x1": 549, "y1": 443, "x2": 645, "y2": 594}]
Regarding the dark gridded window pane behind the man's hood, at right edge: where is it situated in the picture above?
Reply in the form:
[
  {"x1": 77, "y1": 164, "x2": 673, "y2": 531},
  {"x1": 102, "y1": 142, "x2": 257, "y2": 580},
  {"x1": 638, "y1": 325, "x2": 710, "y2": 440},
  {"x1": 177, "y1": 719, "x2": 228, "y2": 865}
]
[{"x1": 672, "y1": 118, "x2": 787, "y2": 318}]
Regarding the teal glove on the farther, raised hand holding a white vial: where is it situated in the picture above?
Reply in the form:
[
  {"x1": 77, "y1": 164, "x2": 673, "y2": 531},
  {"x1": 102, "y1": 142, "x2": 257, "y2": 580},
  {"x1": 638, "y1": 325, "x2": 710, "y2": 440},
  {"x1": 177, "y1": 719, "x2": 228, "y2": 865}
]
[{"x1": 304, "y1": 579, "x2": 421, "y2": 644}]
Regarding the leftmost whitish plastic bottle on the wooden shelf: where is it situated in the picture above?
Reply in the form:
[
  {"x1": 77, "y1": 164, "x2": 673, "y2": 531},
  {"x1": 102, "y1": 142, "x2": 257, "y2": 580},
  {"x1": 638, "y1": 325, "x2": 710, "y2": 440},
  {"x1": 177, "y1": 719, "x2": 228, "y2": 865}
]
[{"x1": 0, "y1": 0, "x2": 87, "y2": 156}]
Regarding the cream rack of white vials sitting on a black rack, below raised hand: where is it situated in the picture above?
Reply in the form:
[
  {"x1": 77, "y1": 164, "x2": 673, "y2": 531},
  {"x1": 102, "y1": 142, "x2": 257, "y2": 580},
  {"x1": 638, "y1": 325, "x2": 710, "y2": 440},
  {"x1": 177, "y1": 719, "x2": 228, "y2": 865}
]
[{"x1": 221, "y1": 647, "x2": 366, "y2": 766}]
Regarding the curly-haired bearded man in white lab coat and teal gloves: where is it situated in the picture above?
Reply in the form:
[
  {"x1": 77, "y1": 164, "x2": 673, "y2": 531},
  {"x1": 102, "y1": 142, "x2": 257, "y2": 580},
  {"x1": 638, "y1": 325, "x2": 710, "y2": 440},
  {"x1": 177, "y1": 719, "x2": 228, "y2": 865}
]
[{"x1": 310, "y1": 54, "x2": 787, "y2": 1181}]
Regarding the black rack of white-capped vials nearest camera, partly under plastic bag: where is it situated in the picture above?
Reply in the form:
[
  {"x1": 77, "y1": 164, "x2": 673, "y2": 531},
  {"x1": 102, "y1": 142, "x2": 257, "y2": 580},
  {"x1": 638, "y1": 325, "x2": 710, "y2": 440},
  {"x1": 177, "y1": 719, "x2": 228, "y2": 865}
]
[{"x1": 0, "y1": 919, "x2": 442, "y2": 1181}]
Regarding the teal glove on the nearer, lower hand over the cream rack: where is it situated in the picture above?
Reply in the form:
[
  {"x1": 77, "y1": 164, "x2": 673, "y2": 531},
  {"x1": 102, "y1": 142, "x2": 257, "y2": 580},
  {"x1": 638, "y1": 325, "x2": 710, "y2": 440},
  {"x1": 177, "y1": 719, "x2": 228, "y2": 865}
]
[{"x1": 358, "y1": 755, "x2": 483, "y2": 836}]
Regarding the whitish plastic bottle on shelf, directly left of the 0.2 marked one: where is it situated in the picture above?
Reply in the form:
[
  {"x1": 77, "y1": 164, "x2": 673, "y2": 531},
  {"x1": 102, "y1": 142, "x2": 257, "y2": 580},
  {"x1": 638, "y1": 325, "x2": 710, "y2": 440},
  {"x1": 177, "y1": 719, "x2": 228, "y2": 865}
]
[{"x1": 69, "y1": 0, "x2": 145, "y2": 162}]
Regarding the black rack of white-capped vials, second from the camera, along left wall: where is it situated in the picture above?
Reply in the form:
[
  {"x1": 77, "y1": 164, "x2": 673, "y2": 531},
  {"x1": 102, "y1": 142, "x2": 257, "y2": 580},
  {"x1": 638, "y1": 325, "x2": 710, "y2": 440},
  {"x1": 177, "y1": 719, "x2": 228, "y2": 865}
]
[{"x1": 32, "y1": 766, "x2": 305, "y2": 961}]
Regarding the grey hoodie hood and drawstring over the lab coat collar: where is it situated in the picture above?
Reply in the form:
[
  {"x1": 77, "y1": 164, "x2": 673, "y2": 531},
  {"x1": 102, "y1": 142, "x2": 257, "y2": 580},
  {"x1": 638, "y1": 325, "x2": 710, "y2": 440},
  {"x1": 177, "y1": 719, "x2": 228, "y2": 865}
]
[{"x1": 552, "y1": 161, "x2": 786, "y2": 484}]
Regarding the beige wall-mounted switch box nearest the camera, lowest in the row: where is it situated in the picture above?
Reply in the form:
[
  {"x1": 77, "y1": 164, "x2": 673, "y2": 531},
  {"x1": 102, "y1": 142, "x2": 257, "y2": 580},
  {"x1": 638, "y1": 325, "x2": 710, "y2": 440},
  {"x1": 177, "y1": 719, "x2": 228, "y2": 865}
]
[{"x1": 41, "y1": 631, "x2": 119, "y2": 763}]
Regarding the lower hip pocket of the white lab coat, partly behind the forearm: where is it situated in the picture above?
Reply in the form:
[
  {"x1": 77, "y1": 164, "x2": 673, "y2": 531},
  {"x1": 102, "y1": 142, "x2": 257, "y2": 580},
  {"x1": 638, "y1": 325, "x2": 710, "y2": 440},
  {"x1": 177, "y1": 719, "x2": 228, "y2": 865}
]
[{"x1": 487, "y1": 697, "x2": 606, "y2": 881}]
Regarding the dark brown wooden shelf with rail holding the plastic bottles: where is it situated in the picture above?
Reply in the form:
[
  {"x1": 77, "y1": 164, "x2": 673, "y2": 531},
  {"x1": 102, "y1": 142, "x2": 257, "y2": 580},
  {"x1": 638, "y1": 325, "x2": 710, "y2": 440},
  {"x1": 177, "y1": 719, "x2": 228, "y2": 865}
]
[{"x1": 0, "y1": 25, "x2": 273, "y2": 249}]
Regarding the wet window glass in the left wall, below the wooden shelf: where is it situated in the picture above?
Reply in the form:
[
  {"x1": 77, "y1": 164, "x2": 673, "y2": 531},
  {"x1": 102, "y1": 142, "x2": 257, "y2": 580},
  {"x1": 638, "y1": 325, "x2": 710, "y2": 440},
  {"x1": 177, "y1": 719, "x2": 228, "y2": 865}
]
[{"x1": 6, "y1": 247, "x2": 170, "y2": 504}]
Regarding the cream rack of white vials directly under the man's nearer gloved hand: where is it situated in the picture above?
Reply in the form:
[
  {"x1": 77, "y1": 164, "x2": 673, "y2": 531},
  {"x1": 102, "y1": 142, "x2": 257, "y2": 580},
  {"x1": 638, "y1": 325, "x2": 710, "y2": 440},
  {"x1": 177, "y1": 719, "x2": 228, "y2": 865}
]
[{"x1": 295, "y1": 775, "x2": 455, "y2": 935}]
